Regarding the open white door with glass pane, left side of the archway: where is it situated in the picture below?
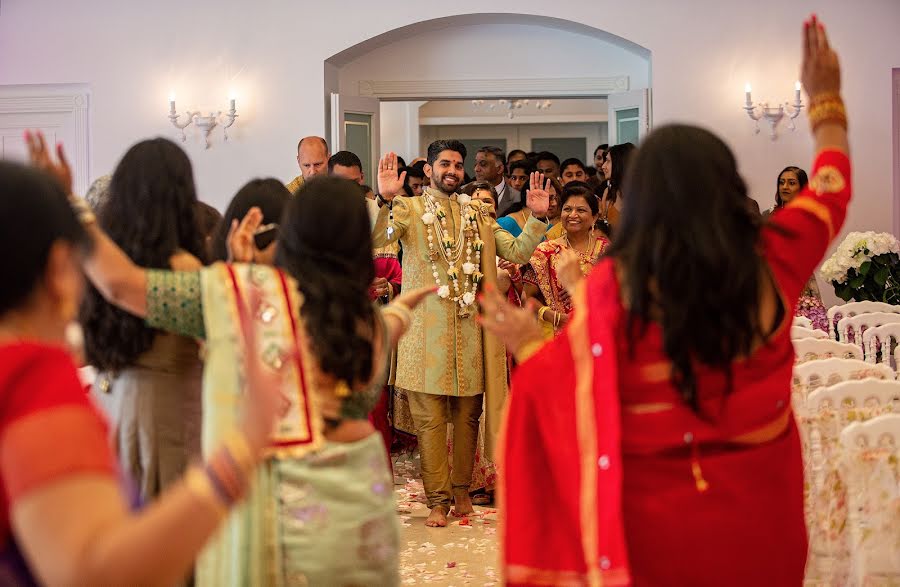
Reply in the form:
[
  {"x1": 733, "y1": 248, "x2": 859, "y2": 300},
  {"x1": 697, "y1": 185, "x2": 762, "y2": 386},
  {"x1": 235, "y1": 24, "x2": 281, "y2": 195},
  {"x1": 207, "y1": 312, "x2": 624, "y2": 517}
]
[{"x1": 331, "y1": 93, "x2": 381, "y2": 189}]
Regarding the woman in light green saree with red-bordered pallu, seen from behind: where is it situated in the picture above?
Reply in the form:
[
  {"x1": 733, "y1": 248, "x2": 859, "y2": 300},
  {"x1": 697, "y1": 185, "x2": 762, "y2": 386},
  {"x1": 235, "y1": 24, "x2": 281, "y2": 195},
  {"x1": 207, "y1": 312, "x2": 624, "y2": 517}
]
[{"x1": 79, "y1": 178, "x2": 431, "y2": 587}]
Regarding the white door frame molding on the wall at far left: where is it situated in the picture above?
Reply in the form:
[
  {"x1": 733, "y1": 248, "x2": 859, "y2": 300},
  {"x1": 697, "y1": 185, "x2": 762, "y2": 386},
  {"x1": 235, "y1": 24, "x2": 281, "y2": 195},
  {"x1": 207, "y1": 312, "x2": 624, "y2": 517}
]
[{"x1": 0, "y1": 84, "x2": 90, "y2": 194}]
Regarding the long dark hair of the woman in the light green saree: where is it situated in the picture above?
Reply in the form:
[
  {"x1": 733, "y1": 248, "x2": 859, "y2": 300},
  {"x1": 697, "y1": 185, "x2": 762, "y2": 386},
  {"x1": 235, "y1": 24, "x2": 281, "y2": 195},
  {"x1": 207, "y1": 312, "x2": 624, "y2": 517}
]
[{"x1": 275, "y1": 177, "x2": 375, "y2": 387}]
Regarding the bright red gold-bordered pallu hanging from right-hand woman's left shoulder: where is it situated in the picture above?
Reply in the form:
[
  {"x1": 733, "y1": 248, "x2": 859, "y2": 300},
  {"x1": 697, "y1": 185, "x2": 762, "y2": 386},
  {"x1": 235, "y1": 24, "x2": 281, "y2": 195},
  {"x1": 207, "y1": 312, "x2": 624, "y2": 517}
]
[{"x1": 500, "y1": 262, "x2": 631, "y2": 586}]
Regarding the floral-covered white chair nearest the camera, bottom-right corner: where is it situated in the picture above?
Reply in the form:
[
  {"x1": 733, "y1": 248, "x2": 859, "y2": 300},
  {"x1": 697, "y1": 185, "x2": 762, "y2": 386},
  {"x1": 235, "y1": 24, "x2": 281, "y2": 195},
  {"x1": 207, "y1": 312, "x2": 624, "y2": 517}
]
[{"x1": 839, "y1": 414, "x2": 900, "y2": 585}]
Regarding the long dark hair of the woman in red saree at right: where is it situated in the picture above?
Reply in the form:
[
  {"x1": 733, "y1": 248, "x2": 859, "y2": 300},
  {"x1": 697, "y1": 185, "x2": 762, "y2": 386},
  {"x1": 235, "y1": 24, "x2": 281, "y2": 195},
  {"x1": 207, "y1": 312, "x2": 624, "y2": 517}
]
[{"x1": 608, "y1": 125, "x2": 763, "y2": 411}]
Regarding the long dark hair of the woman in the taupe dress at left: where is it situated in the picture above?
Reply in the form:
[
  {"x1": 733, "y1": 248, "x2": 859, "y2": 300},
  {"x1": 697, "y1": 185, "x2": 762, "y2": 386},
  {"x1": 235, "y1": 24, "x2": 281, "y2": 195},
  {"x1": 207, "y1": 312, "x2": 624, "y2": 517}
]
[{"x1": 81, "y1": 138, "x2": 205, "y2": 371}]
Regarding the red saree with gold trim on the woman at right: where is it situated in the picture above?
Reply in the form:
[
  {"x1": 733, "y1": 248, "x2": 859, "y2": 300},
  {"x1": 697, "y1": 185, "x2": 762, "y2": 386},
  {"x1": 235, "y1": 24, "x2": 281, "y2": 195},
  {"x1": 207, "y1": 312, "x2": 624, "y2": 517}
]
[{"x1": 500, "y1": 151, "x2": 850, "y2": 586}]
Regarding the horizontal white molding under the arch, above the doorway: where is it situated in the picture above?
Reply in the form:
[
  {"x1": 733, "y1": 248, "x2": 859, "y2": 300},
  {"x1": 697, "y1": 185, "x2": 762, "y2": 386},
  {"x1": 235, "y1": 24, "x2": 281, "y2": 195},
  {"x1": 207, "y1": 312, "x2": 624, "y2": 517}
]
[{"x1": 359, "y1": 75, "x2": 630, "y2": 100}]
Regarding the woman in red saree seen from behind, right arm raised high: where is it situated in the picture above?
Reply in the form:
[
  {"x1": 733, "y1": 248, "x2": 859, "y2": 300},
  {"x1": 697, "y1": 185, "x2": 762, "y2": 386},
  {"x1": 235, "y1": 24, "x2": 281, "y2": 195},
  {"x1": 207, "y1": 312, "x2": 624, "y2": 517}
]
[{"x1": 482, "y1": 18, "x2": 850, "y2": 586}]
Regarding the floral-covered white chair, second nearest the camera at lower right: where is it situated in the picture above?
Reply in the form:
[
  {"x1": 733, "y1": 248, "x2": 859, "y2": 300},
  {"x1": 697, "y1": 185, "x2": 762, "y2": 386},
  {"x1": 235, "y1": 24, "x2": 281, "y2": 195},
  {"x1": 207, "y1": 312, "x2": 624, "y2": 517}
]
[{"x1": 802, "y1": 378, "x2": 900, "y2": 585}]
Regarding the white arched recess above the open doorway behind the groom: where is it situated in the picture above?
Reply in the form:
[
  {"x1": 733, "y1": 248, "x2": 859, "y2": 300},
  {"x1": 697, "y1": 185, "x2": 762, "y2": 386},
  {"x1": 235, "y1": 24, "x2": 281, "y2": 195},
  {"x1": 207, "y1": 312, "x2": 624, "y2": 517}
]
[{"x1": 324, "y1": 13, "x2": 651, "y2": 178}]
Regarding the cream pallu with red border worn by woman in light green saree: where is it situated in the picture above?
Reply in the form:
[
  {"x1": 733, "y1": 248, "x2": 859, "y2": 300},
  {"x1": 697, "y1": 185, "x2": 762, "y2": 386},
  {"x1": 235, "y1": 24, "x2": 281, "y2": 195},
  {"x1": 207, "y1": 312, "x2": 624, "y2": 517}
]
[{"x1": 197, "y1": 263, "x2": 323, "y2": 587}]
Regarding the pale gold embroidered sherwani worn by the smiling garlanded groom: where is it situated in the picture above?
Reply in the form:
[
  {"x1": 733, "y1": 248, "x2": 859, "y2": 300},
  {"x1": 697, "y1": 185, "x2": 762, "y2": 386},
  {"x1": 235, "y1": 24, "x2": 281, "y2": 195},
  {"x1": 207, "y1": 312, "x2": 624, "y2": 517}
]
[{"x1": 372, "y1": 188, "x2": 547, "y2": 460}]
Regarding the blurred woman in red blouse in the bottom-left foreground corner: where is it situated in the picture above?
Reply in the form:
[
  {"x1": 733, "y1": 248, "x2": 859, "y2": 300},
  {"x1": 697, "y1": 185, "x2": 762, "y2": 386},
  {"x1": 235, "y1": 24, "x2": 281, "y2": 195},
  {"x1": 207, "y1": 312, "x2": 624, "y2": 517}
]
[{"x1": 0, "y1": 136, "x2": 278, "y2": 585}]
